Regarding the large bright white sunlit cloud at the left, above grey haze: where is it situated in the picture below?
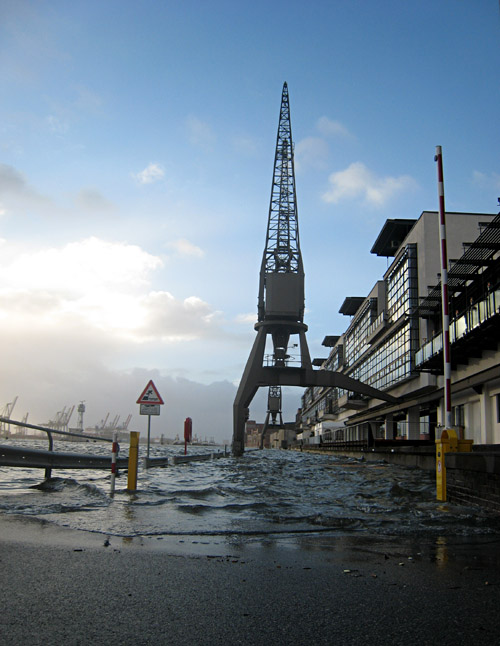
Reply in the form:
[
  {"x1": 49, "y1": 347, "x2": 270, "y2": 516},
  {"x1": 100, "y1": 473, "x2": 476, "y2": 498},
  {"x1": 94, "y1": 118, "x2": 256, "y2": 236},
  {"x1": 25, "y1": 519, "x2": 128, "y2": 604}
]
[{"x1": 0, "y1": 238, "x2": 225, "y2": 343}]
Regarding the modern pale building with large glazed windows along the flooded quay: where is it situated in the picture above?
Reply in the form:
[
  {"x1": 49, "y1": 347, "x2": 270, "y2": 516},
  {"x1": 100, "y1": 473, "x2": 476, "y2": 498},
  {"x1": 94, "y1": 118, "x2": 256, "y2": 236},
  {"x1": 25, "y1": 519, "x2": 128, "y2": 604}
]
[{"x1": 299, "y1": 211, "x2": 500, "y2": 445}]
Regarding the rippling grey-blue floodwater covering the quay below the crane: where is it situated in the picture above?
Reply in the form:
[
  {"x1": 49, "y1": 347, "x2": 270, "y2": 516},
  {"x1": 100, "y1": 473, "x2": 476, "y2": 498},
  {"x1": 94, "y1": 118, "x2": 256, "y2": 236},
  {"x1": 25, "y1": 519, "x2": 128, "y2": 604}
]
[{"x1": 0, "y1": 440, "x2": 500, "y2": 540}]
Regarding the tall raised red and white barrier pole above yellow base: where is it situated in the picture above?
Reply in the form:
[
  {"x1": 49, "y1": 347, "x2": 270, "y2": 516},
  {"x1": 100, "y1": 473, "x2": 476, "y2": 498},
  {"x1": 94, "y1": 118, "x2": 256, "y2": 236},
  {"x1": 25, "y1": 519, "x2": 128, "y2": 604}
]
[{"x1": 434, "y1": 146, "x2": 451, "y2": 428}]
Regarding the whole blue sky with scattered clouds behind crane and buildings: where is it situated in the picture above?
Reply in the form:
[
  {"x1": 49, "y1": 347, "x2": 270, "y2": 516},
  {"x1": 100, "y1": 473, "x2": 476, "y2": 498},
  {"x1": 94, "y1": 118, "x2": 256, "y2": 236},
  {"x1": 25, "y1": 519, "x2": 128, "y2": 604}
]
[{"x1": 0, "y1": 0, "x2": 500, "y2": 438}]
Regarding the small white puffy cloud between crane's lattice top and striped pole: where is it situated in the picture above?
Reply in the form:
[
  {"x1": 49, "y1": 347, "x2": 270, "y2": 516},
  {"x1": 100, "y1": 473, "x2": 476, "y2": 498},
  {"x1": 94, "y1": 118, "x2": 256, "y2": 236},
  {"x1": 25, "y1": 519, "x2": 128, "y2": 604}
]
[{"x1": 322, "y1": 162, "x2": 417, "y2": 207}]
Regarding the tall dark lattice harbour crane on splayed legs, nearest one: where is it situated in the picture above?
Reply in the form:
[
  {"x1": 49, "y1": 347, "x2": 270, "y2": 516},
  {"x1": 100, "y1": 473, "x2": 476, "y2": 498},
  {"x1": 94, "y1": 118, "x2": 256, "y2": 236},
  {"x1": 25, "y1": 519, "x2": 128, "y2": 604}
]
[{"x1": 232, "y1": 83, "x2": 397, "y2": 456}]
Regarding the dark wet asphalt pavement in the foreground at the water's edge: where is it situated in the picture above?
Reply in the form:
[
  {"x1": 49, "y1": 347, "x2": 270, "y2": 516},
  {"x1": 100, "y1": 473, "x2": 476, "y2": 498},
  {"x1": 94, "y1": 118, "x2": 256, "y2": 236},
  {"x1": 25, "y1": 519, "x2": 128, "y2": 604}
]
[{"x1": 0, "y1": 515, "x2": 500, "y2": 646}]
